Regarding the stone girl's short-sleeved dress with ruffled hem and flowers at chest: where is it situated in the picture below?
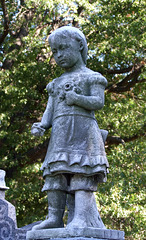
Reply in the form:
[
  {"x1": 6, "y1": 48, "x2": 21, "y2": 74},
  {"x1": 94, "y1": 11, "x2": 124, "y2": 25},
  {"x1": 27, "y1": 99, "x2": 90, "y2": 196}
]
[{"x1": 41, "y1": 70, "x2": 109, "y2": 182}]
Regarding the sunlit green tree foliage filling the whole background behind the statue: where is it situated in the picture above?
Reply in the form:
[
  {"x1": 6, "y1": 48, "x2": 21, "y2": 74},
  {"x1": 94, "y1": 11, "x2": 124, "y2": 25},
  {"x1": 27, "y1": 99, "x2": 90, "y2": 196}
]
[{"x1": 0, "y1": 0, "x2": 146, "y2": 240}]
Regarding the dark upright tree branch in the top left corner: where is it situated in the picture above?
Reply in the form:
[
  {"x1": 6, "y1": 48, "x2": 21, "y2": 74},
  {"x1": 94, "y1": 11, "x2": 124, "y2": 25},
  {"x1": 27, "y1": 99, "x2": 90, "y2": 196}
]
[{"x1": 0, "y1": 0, "x2": 9, "y2": 45}]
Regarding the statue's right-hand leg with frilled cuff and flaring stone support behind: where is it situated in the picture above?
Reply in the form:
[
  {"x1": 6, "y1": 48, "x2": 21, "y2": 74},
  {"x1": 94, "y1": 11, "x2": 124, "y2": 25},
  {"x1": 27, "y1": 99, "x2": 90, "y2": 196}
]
[{"x1": 67, "y1": 176, "x2": 105, "y2": 228}]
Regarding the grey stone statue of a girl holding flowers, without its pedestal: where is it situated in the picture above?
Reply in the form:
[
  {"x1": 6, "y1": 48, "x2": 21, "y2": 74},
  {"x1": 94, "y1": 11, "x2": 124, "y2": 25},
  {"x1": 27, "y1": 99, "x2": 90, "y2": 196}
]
[{"x1": 32, "y1": 26, "x2": 109, "y2": 230}]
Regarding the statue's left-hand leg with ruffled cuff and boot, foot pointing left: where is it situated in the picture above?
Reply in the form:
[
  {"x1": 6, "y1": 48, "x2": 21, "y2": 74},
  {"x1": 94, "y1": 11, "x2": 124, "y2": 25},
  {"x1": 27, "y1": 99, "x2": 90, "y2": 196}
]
[{"x1": 32, "y1": 175, "x2": 66, "y2": 230}]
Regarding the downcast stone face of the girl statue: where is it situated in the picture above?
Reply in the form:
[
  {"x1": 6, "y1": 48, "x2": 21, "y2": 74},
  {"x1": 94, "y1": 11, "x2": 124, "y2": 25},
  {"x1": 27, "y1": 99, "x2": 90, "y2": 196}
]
[{"x1": 50, "y1": 35, "x2": 83, "y2": 70}]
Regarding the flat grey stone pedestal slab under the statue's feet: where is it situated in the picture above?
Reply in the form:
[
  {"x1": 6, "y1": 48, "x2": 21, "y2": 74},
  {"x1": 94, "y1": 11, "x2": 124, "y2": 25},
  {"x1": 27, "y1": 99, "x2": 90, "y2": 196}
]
[{"x1": 26, "y1": 228, "x2": 124, "y2": 240}]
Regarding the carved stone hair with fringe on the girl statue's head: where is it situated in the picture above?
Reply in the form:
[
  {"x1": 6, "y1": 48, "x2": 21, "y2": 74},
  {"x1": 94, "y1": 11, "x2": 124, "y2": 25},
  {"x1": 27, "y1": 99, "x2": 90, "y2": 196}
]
[{"x1": 49, "y1": 26, "x2": 88, "y2": 64}]
